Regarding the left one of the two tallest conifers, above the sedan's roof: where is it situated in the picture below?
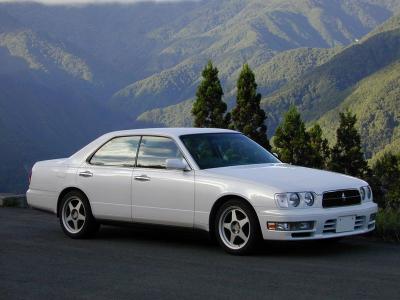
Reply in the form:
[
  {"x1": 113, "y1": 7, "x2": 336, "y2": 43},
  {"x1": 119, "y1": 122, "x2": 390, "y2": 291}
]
[{"x1": 192, "y1": 61, "x2": 229, "y2": 128}]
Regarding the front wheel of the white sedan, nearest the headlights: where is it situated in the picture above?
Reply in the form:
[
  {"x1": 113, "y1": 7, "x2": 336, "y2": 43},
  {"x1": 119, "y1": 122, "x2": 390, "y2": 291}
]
[{"x1": 214, "y1": 199, "x2": 261, "y2": 255}]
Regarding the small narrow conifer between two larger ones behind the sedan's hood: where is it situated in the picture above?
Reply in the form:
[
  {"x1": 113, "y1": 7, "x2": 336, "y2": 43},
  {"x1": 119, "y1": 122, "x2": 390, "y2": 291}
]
[{"x1": 308, "y1": 124, "x2": 330, "y2": 169}]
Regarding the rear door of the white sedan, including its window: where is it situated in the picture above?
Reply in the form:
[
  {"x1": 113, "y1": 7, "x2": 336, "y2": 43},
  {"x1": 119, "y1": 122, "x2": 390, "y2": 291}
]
[{"x1": 78, "y1": 136, "x2": 140, "y2": 221}]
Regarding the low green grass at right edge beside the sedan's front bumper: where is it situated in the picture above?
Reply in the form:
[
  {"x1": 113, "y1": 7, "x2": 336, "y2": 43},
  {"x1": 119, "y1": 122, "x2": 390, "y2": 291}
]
[{"x1": 375, "y1": 208, "x2": 400, "y2": 242}]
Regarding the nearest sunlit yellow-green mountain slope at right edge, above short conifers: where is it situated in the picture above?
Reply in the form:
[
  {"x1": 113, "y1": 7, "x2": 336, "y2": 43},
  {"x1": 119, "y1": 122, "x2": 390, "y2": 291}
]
[{"x1": 318, "y1": 60, "x2": 400, "y2": 161}]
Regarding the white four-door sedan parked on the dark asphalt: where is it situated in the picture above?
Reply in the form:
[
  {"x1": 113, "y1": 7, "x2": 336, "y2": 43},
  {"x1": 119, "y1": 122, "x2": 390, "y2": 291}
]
[{"x1": 27, "y1": 128, "x2": 377, "y2": 254}]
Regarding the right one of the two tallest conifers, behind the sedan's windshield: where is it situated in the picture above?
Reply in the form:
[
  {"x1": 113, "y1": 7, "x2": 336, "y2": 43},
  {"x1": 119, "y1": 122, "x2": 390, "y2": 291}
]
[{"x1": 231, "y1": 64, "x2": 271, "y2": 150}]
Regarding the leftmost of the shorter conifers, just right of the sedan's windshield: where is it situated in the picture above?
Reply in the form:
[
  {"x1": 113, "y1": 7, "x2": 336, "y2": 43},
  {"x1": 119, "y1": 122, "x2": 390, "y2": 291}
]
[{"x1": 274, "y1": 105, "x2": 311, "y2": 166}]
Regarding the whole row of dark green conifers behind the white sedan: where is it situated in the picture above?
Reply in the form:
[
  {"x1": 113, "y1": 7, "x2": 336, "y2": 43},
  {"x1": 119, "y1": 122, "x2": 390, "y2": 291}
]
[{"x1": 192, "y1": 61, "x2": 400, "y2": 209}]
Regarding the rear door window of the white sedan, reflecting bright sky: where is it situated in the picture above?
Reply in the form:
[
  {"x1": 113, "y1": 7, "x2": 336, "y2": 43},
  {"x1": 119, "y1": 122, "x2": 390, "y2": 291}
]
[{"x1": 90, "y1": 136, "x2": 140, "y2": 167}]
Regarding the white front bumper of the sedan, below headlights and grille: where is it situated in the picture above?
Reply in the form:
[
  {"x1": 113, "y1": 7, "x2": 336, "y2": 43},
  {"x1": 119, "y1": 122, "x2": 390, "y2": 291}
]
[{"x1": 257, "y1": 202, "x2": 378, "y2": 240}]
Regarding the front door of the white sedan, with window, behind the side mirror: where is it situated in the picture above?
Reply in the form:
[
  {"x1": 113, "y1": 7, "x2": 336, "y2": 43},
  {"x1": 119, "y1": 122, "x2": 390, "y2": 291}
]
[{"x1": 132, "y1": 136, "x2": 194, "y2": 227}]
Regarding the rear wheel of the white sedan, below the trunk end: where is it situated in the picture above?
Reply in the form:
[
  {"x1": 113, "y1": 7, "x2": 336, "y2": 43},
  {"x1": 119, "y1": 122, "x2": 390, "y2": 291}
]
[{"x1": 59, "y1": 191, "x2": 100, "y2": 239}]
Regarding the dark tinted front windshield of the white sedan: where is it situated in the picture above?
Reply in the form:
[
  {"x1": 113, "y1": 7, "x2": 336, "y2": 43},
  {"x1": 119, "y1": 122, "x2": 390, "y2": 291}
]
[{"x1": 180, "y1": 133, "x2": 280, "y2": 169}]
